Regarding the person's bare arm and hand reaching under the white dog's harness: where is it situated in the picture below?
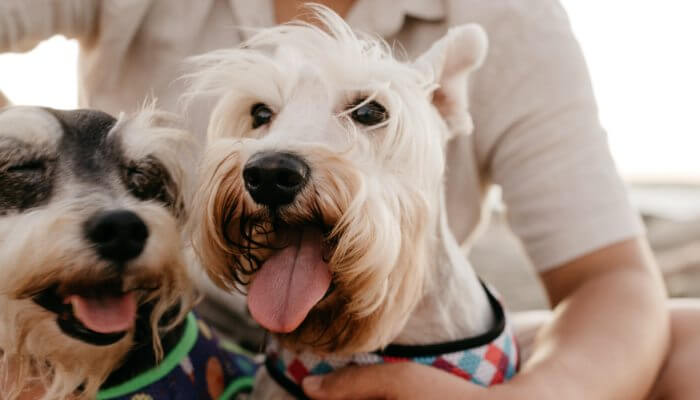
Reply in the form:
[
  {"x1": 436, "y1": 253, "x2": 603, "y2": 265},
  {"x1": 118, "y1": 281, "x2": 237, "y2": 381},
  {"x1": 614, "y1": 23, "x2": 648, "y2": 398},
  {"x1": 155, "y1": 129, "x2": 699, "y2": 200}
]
[{"x1": 304, "y1": 239, "x2": 669, "y2": 400}]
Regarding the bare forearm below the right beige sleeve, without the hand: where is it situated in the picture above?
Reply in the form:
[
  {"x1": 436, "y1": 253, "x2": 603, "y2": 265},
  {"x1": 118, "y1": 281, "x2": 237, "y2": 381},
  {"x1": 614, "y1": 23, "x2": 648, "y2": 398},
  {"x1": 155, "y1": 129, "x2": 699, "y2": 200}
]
[{"x1": 498, "y1": 240, "x2": 669, "y2": 400}]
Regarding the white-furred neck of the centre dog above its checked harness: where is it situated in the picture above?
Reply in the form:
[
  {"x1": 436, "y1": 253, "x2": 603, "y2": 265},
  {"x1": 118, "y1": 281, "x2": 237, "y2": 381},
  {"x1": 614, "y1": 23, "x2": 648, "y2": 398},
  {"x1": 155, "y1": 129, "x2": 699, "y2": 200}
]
[{"x1": 393, "y1": 202, "x2": 494, "y2": 345}]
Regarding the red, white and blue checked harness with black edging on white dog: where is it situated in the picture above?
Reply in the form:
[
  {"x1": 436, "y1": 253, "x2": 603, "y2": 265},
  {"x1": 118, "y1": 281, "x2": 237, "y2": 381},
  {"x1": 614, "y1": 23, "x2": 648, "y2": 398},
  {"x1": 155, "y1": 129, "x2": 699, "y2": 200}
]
[{"x1": 265, "y1": 285, "x2": 519, "y2": 399}]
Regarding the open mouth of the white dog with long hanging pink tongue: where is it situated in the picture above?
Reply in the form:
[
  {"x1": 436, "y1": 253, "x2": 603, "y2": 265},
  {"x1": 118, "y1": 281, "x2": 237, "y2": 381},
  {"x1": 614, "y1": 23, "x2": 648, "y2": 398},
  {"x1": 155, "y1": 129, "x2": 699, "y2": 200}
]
[{"x1": 232, "y1": 210, "x2": 332, "y2": 333}]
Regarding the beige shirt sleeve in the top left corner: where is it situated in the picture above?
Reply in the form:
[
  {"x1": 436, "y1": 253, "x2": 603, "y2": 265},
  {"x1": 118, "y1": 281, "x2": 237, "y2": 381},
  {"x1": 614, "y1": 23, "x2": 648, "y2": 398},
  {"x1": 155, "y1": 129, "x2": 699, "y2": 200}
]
[{"x1": 0, "y1": 0, "x2": 100, "y2": 52}]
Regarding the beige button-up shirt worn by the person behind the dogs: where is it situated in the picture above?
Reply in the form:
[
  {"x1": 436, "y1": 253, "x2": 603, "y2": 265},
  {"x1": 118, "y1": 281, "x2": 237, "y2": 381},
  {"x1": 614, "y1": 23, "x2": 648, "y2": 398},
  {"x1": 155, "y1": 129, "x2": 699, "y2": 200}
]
[{"x1": 0, "y1": 0, "x2": 642, "y2": 271}]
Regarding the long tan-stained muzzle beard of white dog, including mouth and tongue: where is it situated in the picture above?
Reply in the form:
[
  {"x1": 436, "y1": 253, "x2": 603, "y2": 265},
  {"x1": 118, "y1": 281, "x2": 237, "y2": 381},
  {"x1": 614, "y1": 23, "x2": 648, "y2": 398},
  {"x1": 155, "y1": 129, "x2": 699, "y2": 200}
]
[{"x1": 193, "y1": 140, "x2": 431, "y2": 353}]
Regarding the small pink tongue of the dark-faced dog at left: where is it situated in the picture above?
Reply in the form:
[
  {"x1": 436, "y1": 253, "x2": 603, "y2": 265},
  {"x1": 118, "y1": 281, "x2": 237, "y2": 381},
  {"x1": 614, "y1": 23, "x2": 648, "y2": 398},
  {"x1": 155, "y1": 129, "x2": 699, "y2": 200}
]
[{"x1": 66, "y1": 293, "x2": 137, "y2": 333}]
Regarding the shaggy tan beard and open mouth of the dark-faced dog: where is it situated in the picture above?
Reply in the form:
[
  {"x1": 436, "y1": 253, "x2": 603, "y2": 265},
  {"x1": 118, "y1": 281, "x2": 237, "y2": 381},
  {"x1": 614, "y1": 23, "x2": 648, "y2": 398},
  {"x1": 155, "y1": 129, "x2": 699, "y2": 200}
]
[{"x1": 0, "y1": 266, "x2": 194, "y2": 399}]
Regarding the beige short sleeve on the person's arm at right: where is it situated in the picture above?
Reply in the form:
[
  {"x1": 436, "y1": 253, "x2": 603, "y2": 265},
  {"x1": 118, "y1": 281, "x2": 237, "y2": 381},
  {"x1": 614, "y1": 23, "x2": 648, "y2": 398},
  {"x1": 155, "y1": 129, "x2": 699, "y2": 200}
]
[{"x1": 471, "y1": 0, "x2": 644, "y2": 271}]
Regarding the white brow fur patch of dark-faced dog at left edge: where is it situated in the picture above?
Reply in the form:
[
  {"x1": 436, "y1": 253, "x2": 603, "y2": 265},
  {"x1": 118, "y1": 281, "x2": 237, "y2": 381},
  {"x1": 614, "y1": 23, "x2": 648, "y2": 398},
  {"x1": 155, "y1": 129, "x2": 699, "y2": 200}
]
[{"x1": 0, "y1": 106, "x2": 63, "y2": 147}]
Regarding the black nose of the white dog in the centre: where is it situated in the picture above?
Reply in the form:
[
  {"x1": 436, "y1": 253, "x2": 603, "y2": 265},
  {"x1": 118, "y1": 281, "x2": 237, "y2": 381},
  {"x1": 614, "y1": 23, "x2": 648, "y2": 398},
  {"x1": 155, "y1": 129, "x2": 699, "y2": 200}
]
[{"x1": 243, "y1": 152, "x2": 309, "y2": 207}]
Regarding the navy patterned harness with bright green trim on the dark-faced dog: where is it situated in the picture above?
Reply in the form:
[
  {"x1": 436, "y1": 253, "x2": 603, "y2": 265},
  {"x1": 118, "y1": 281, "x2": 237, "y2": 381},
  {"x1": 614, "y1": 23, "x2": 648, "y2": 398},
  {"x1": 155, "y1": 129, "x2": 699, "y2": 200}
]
[{"x1": 97, "y1": 313, "x2": 258, "y2": 400}]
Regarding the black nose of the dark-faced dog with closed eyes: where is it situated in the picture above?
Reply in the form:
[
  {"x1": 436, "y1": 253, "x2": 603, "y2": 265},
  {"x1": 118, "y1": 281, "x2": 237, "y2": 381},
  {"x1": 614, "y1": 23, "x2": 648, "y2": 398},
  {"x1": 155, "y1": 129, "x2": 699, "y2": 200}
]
[{"x1": 85, "y1": 210, "x2": 148, "y2": 263}]
